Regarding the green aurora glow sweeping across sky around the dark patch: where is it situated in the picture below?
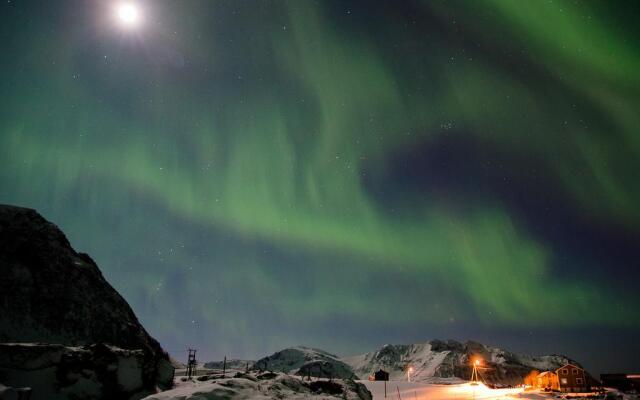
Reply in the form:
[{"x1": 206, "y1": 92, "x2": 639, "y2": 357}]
[{"x1": 0, "y1": 0, "x2": 640, "y2": 356}]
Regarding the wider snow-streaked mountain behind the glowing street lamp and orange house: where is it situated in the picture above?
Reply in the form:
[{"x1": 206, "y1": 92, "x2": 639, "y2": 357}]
[{"x1": 341, "y1": 340, "x2": 579, "y2": 384}]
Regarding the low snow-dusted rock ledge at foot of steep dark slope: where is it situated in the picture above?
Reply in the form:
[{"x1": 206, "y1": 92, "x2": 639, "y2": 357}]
[{"x1": 0, "y1": 343, "x2": 173, "y2": 400}]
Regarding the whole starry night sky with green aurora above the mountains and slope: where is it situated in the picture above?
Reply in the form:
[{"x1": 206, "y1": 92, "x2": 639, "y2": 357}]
[{"x1": 0, "y1": 0, "x2": 640, "y2": 373}]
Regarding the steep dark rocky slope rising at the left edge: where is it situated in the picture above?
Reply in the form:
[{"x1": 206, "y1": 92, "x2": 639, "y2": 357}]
[{"x1": 0, "y1": 205, "x2": 173, "y2": 399}]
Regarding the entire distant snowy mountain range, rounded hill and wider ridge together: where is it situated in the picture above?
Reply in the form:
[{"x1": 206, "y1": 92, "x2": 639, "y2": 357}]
[{"x1": 253, "y1": 340, "x2": 580, "y2": 385}]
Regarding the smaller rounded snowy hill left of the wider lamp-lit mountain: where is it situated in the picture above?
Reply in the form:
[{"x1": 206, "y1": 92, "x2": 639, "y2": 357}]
[{"x1": 253, "y1": 346, "x2": 356, "y2": 379}]
